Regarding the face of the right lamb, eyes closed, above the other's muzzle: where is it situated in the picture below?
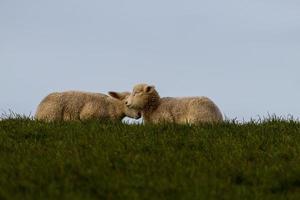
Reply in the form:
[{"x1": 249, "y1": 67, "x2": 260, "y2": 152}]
[{"x1": 126, "y1": 84, "x2": 155, "y2": 110}]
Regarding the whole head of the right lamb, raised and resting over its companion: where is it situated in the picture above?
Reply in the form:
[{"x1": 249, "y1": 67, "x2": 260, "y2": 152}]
[{"x1": 126, "y1": 84, "x2": 160, "y2": 111}]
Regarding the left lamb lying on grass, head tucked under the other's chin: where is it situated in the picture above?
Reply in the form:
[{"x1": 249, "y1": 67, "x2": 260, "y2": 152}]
[{"x1": 35, "y1": 91, "x2": 141, "y2": 122}]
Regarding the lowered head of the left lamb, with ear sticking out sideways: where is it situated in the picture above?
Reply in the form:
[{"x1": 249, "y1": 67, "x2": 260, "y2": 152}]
[{"x1": 108, "y1": 92, "x2": 142, "y2": 119}]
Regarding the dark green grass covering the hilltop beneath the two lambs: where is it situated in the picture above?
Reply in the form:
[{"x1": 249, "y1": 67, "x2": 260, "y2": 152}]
[{"x1": 0, "y1": 118, "x2": 300, "y2": 200}]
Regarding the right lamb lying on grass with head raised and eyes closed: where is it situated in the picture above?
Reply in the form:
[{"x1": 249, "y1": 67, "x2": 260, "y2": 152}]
[{"x1": 126, "y1": 84, "x2": 223, "y2": 124}]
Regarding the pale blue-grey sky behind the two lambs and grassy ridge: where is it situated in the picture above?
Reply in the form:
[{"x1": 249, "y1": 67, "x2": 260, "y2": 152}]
[{"x1": 0, "y1": 0, "x2": 300, "y2": 120}]
